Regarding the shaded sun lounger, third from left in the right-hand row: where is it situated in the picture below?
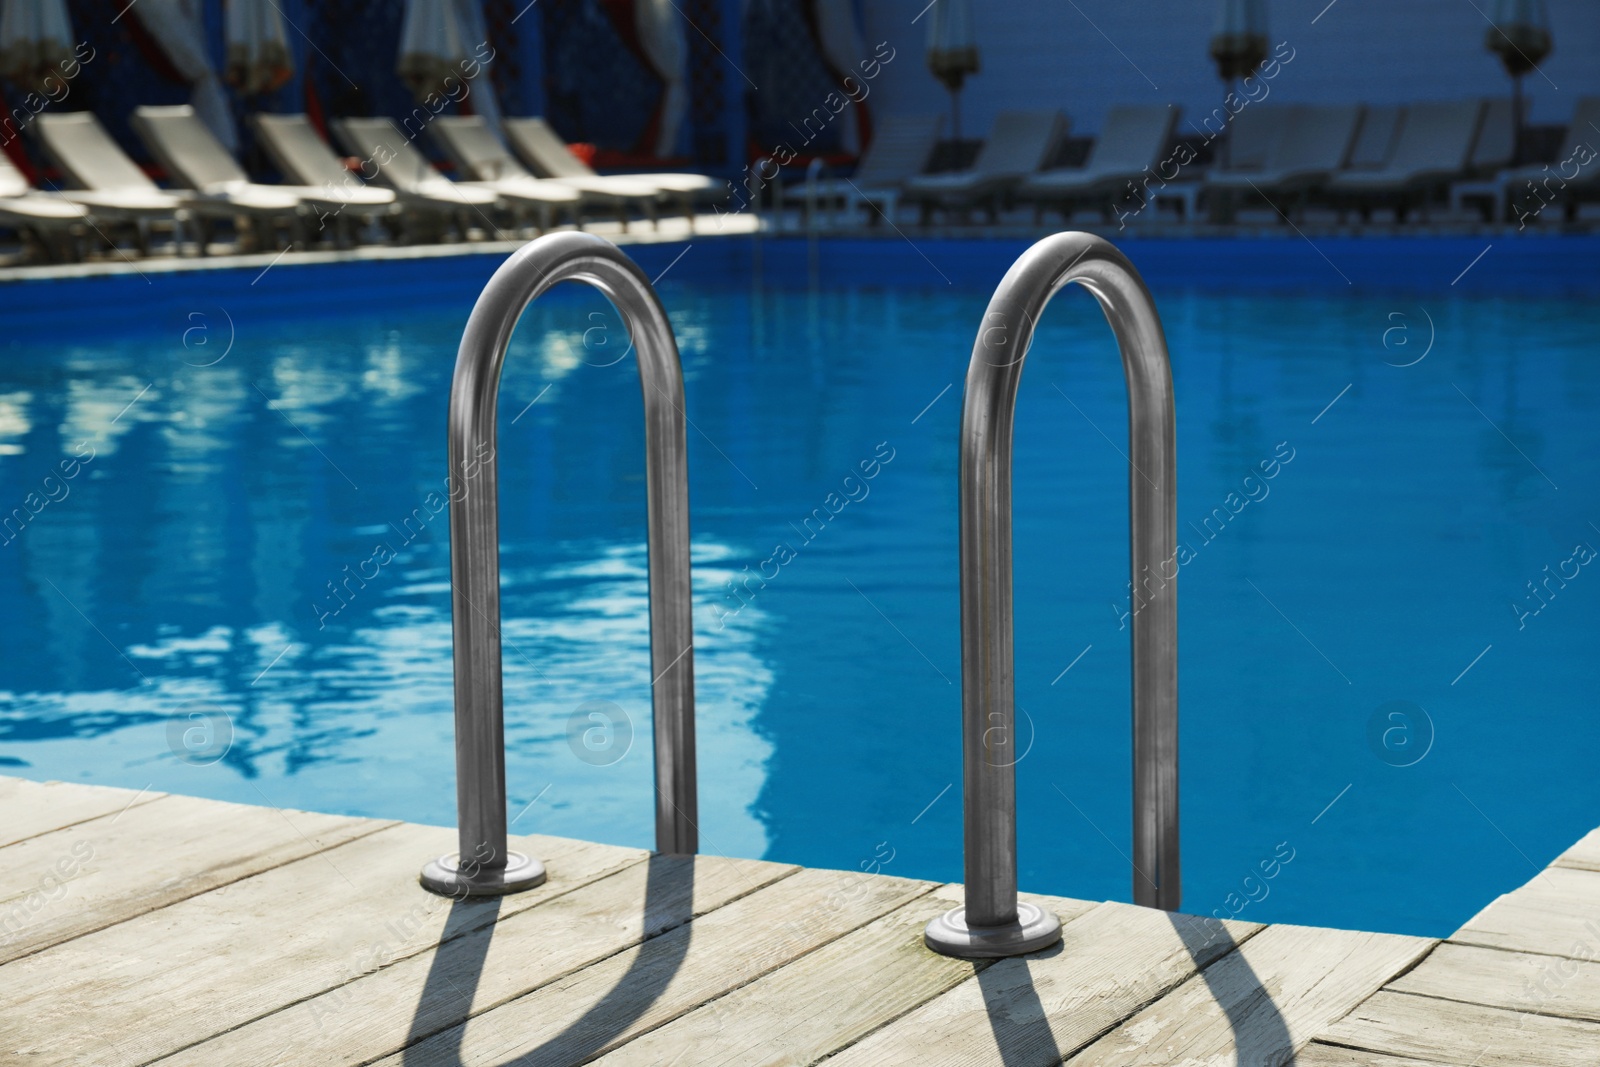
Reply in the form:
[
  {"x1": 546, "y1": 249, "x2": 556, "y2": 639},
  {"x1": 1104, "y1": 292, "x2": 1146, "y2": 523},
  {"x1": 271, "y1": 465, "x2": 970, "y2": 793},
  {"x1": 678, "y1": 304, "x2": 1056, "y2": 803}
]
[{"x1": 1016, "y1": 104, "x2": 1178, "y2": 218}]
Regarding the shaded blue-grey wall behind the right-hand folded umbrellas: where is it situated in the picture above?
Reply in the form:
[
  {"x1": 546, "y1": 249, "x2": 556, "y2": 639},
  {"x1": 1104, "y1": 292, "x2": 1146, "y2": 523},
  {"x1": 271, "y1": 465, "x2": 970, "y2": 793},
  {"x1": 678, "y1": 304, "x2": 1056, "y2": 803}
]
[{"x1": 864, "y1": 0, "x2": 1600, "y2": 136}]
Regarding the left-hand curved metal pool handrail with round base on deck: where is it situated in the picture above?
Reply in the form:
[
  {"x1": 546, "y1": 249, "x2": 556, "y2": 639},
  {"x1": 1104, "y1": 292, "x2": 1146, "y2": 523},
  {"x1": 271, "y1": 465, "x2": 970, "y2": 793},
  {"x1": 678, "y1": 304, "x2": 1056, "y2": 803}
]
[{"x1": 422, "y1": 232, "x2": 699, "y2": 896}]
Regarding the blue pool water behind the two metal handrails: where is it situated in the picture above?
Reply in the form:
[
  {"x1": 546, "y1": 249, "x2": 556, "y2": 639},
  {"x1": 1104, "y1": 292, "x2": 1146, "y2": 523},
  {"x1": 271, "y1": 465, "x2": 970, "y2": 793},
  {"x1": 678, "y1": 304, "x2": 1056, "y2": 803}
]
[{"x1": 0, "y1": 238, "x2": 1600, "y2": 934}]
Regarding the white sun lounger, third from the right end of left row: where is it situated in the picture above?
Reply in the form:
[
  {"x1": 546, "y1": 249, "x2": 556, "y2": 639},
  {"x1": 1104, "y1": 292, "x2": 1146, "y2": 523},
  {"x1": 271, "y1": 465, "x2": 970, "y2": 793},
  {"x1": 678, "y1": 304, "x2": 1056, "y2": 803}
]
[{"x1": 333, "y1": 118, "x2": 579, "y2": 230}]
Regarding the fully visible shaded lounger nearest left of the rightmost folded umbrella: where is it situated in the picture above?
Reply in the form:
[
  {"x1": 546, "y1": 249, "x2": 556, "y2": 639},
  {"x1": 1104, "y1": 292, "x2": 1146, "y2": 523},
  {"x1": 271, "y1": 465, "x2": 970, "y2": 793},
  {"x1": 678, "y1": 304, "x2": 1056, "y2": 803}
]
[{"x1": 1325, "y1": 101, "x2": 1483, "y2": 219}]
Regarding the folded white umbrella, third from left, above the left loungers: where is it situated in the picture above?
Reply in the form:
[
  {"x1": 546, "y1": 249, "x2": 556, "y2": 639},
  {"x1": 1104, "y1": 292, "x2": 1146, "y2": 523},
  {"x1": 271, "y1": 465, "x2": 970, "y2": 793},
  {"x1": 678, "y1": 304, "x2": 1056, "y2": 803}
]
[{"x1": 395, "y1": 0, "x2": 499, "y2": 130}]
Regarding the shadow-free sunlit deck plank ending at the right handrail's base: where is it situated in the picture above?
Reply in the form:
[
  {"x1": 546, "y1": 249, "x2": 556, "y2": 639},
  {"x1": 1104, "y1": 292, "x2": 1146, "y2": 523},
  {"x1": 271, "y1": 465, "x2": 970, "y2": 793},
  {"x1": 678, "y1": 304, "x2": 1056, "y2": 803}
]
[{"x1": 598, "y1": 886, "x2": 1094, "y2": 1067}]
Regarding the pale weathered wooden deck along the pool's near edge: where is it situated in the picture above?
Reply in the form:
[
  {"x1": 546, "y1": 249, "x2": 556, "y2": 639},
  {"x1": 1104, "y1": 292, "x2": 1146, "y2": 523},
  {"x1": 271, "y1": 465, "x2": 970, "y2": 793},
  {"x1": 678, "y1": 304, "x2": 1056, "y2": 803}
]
[{"x1": 0, "y1": 777, "x2": 1600, "y2": 1067}]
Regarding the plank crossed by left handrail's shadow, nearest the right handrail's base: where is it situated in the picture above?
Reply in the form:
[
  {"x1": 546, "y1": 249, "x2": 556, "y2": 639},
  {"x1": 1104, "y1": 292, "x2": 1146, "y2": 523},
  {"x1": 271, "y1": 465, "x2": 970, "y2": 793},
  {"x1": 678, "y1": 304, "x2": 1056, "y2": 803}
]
[{"x1": 379, "y1": 870, "x2": 934, "y2": 1067}]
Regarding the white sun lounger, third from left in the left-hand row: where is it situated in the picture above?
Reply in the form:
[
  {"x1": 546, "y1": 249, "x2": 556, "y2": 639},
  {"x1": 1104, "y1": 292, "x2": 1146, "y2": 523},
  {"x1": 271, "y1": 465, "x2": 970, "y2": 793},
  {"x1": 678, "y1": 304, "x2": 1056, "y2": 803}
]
[{"x1": 133, "y1": 104, "x2": 395, "y2": 242}]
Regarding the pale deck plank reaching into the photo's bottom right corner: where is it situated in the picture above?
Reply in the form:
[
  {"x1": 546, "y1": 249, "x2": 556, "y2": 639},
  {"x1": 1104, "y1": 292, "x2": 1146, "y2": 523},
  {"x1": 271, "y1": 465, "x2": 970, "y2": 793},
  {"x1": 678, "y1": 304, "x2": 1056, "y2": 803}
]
[{"x1": 1318, "y1": 990, "x2": 1600, "y2": 1067}]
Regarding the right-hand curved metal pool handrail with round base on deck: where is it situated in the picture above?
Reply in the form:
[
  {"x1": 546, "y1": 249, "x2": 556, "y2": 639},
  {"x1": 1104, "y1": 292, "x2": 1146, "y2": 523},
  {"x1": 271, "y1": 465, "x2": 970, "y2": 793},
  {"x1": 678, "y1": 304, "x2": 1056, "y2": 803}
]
[{"x1": 923, "y1": 234, "x2": 1181, "y2": 957}]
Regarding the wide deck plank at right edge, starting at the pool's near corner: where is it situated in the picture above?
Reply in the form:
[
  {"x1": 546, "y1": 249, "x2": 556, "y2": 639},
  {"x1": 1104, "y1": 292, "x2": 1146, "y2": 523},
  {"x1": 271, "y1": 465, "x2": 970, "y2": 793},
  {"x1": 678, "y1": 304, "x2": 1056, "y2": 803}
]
[{"x1": 1450, "y1": 867, "x2": 1600, "y2": 957}]
